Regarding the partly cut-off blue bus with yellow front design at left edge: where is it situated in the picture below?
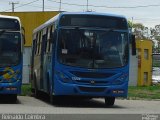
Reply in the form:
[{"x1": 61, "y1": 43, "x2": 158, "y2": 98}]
[{"x1": 0, "y1": 15, "x2": 23, "y2": 102}]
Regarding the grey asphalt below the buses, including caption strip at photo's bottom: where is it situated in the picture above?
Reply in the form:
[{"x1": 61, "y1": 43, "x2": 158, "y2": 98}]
[{"x1": 0, "y1": 96, "x2": 160, "y2": 120}]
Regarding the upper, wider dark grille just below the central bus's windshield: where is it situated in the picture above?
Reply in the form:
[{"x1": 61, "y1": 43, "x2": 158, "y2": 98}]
[{"x1": 71, "y1": 71, "x2": 114, "y2": 78}]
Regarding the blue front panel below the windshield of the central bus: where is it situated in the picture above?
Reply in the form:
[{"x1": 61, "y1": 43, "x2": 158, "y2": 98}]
[{"x1": 53, "y1": 63, "x2": 129, "y2": 97}]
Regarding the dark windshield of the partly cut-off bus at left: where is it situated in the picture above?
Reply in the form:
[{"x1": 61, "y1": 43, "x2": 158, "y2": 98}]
[{"x1": 0, "y1": 31, "x2": 21, "y2": 67}]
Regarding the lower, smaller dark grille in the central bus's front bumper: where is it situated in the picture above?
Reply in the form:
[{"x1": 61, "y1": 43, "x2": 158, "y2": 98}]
[{"x1": 79, "y1": 86, "x2": 105, "y2": 92}]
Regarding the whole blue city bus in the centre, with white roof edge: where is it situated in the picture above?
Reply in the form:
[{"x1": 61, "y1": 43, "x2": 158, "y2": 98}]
[{"x1": 31, "y1": 12, "x2": 135, "y2": 106}]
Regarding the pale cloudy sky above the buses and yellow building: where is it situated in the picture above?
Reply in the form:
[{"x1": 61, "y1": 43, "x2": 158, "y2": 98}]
[{"x1": 0, "y1": 0, "x2": 160, "y2": 27}]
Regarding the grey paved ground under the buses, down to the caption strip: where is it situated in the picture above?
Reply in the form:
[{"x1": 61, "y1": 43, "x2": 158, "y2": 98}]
[{"x1": 0, "y1": 96, "x2": 160, "y2": 114}]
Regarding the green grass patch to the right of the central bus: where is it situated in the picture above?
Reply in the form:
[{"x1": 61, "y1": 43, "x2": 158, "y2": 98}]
[{"x1": 128, "y1": 85, "x2": 160, "y2": 100}]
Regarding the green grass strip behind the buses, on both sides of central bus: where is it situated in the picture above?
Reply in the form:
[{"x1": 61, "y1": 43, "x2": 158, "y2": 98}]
[{"x1": 21, "y1": 84, "x2": 160, "y2": 100}]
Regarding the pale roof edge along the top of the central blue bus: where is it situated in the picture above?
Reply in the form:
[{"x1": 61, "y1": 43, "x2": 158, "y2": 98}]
[{"x1": 33, "y1": 12, "x2": 126, "y2": 33}]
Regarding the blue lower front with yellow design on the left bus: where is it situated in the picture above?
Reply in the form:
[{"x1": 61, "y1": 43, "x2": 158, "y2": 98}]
[{"x1": 0, "y1": 62, "x2": 22, "y2": 94}]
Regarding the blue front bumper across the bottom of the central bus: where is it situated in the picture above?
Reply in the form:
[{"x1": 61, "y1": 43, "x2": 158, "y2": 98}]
[{"x1": 53, "y1": 80, "x2": 128, "y2": 98}]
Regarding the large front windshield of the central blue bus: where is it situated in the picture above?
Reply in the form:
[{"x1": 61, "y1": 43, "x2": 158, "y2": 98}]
[{"x1": 58, "y1": 28, "x2": 128, "y2": 68}]
